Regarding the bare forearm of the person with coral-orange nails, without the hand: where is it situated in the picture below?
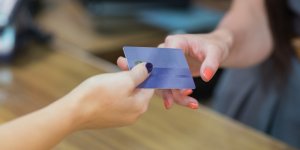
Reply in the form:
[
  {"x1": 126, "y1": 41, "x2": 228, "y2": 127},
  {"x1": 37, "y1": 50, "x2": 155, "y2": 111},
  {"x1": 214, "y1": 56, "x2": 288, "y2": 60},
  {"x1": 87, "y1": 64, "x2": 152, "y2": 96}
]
[{"x1": 216, "y1": 0, "x2": 272, "y2": 67}]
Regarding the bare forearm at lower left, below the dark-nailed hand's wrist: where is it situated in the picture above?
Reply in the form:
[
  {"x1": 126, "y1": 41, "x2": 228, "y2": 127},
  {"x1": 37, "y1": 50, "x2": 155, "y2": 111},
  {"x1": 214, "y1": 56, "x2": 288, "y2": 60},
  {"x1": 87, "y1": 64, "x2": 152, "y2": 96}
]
[{"x1": 0, "y1": 101, "x2": 76, "y2": 150}]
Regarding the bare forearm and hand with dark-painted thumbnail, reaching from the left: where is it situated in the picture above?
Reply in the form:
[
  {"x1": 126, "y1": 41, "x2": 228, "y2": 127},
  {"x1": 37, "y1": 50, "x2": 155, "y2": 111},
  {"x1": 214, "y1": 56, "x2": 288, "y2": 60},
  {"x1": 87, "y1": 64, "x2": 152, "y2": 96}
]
[{"x1": 0, "y1": 63, "x2": 154, "y2": 150}]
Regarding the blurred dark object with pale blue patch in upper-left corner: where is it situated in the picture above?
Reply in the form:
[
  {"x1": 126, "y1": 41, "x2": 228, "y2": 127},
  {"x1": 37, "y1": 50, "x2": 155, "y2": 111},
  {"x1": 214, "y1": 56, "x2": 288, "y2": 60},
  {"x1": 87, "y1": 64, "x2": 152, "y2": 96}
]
[{"x1": 0, "y1": 0, "x2": 52, "y2": 63}]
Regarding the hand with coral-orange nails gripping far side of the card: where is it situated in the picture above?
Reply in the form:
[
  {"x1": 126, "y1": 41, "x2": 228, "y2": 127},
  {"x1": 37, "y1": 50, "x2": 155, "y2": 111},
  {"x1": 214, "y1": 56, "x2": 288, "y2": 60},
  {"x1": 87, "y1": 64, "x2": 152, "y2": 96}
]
[{"x1": 117, "y1": 30, "x2": 232, "y2": 109}]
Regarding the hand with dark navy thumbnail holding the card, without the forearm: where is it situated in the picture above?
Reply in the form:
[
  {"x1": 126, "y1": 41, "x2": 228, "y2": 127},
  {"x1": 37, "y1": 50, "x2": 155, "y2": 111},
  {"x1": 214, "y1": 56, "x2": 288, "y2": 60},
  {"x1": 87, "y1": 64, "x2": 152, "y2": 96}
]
[{"x1": 63, "y1": 63, "x2": 154, "y2": 129}]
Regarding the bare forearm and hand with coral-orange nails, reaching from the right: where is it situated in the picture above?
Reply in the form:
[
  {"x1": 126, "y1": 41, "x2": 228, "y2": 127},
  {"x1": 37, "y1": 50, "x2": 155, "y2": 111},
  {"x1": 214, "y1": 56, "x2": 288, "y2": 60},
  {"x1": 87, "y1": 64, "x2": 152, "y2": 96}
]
[{"x1": 118, "y1": 0, "x2": 273, "y2": 109}]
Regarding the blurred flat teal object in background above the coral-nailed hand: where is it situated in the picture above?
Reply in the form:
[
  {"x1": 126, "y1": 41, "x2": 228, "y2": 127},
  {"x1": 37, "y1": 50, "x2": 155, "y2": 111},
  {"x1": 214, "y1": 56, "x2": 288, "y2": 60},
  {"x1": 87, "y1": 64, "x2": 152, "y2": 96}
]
[{"x1": 138, "y1": 6, "x2": 224, "y2": 33}]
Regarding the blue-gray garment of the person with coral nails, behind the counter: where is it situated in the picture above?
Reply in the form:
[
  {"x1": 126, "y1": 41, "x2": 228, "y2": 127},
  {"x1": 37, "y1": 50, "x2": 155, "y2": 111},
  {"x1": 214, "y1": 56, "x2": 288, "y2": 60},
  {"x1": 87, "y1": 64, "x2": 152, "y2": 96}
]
[{"x1": 213, "y1": 0, "x2": 300, "y2": 148}]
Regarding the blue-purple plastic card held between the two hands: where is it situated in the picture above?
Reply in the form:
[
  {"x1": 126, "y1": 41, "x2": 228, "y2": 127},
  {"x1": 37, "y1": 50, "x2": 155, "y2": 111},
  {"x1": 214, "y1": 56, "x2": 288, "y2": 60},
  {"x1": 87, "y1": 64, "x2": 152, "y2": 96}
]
[{"x1": 123, "y1": 46, "x2": 195, "y2": 89}]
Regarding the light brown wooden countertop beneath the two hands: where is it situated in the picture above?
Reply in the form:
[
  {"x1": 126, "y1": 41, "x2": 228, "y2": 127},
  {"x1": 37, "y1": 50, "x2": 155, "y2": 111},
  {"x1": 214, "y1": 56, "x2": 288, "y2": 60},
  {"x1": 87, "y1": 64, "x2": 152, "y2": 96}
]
[{"x1": 0, "y1": 46, "x2": 291, "y2": 150}]
